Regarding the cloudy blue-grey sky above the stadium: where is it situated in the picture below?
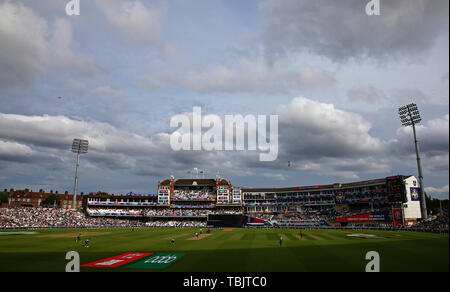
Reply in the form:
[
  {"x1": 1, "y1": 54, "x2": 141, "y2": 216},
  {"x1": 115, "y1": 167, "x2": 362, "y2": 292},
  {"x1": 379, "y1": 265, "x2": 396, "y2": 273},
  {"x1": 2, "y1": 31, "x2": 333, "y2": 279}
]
[{"x1": 0, "y1": 0, "x2": 449, "y2": 198}]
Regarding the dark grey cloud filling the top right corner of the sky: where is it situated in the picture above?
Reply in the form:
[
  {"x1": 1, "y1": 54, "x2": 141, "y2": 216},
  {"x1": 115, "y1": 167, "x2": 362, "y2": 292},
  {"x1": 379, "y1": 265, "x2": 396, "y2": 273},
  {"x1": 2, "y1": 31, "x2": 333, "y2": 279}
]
[{"x1": 260, "y1": 0, "x2": 449, "y2": 61}]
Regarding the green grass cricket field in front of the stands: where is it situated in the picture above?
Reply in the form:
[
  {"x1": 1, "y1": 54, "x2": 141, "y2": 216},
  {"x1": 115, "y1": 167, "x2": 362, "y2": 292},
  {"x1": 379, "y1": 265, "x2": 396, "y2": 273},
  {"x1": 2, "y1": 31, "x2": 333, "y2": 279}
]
[{"x1": 0, "y1": 229, "x2": 449, "y2": 272}]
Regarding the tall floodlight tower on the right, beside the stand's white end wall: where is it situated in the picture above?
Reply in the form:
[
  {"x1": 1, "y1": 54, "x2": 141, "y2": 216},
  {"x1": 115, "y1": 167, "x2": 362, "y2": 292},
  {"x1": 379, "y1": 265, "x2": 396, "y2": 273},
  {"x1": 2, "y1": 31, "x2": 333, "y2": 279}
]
[{"x1": 398, "y1": 103, "x2": 428, "y2": 219}]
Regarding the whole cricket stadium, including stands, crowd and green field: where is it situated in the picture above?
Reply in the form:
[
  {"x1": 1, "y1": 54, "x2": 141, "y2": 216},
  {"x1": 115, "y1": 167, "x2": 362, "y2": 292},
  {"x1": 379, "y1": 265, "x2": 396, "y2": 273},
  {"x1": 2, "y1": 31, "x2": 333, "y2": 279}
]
[{"x1": 0, "y1": 175, "x2": 448, "y2": 272}]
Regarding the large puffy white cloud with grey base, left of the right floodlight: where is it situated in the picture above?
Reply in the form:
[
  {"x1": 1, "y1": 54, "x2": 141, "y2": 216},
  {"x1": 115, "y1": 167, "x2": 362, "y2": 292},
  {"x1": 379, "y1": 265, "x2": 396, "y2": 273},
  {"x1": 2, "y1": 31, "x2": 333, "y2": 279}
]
[{"x1": 242, "y1": 97, "x2": 390, "y2": 179}]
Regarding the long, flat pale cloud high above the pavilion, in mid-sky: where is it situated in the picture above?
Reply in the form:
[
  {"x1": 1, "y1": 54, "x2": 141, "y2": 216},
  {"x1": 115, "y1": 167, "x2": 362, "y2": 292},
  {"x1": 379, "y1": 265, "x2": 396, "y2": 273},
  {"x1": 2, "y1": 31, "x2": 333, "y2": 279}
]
[{"x1": 140, "y1": 58, "x2": 336, "y2": 93}]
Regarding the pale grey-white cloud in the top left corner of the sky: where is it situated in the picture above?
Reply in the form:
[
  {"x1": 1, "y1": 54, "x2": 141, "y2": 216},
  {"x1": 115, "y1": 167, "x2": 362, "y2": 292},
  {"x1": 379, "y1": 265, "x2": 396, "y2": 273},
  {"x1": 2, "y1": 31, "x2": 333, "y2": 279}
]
[{"x1": 0, "y1": 1, "x2": 96, "y2": 87}]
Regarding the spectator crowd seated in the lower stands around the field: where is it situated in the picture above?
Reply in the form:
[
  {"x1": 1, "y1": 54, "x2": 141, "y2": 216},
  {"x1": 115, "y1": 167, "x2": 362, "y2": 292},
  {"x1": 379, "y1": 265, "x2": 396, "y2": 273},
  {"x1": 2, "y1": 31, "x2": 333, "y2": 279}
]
[{"x1": 0, "y1": 208, "x2": 449, "y2": 232}]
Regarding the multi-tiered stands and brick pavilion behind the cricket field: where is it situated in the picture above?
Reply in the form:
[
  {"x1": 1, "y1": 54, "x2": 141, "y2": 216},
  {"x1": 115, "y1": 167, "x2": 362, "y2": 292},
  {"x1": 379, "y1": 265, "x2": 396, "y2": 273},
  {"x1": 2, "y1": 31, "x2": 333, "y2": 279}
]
[{"x1": 1, "y1": 175, "x2": 440, "y2": 228}]
